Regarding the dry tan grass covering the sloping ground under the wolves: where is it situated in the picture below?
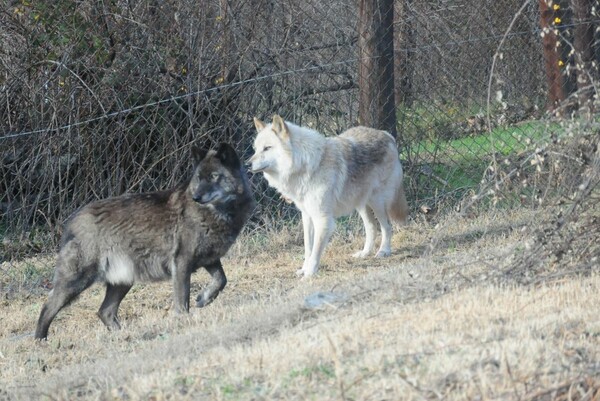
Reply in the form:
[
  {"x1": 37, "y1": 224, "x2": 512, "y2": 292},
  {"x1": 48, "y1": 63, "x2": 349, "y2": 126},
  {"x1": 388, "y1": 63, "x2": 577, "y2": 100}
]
[{"x1": 0, "y1": 210, "x2": 600, "y2": 400}]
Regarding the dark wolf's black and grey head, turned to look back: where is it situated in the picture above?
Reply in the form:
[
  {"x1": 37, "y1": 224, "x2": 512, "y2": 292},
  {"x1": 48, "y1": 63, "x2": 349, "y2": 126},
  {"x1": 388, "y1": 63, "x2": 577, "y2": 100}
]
[{"x1": 187, "y1": 143, "x2": 249, "y2": 205}]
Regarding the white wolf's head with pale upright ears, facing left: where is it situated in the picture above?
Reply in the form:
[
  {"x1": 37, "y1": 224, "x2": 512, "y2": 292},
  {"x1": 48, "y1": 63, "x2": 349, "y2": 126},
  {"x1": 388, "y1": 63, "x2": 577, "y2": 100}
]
[{"x1": 248, "y1": 115, "x2": 293, "y2": 174}]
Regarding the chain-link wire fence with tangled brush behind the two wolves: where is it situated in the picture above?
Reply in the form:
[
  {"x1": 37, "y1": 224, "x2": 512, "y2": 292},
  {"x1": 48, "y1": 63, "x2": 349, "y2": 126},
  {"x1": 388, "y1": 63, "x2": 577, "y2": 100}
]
[{"x1": 0, "y1": 0, "x2": 600, "y2": 261}]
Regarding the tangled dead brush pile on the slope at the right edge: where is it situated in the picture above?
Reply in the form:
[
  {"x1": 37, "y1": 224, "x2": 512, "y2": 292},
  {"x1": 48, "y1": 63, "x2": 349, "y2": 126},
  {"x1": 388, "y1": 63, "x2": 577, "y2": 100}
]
[{"x1": 478, "y1": 127, "x2": 600, "y2": 285}]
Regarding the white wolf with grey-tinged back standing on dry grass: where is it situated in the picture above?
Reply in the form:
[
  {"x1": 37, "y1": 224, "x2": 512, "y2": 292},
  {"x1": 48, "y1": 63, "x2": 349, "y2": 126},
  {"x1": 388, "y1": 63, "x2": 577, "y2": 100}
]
[{"x1": 249, "y1": 115, "x2": 408, "y2": 277}]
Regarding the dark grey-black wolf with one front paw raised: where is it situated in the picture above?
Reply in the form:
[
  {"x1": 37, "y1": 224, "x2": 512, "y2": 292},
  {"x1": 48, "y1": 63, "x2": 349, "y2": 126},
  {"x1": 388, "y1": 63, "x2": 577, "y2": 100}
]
[{"x1": 35, "y1": 144, "x2": 254, "y2": 339}]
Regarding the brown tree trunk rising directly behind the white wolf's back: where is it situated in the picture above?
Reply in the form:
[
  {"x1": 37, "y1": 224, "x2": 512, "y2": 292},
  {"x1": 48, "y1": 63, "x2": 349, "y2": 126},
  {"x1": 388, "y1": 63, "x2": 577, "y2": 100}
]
[{"x1": 358, "y1": 0, "x2": 396, "y2": 137}]
